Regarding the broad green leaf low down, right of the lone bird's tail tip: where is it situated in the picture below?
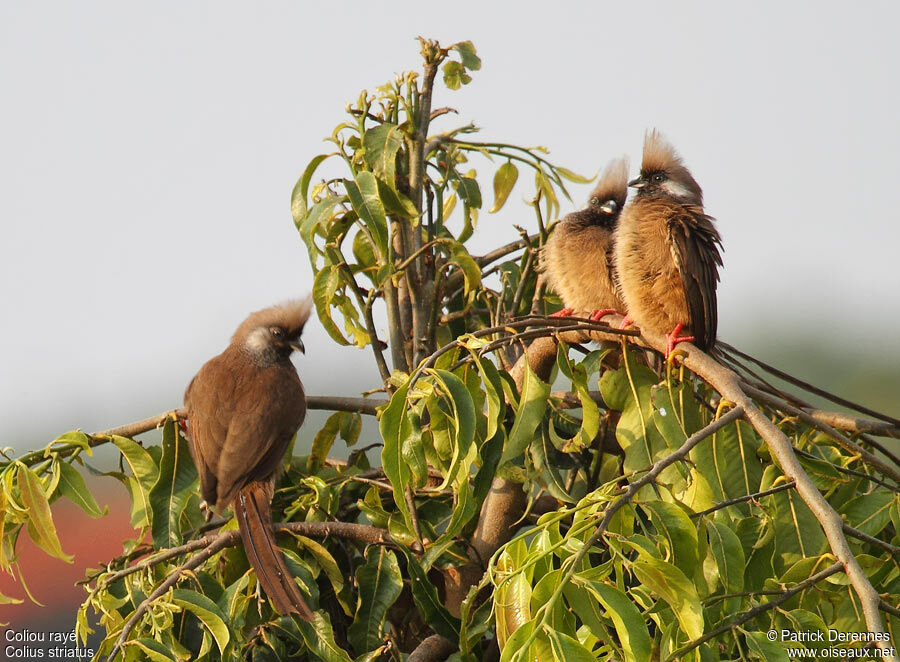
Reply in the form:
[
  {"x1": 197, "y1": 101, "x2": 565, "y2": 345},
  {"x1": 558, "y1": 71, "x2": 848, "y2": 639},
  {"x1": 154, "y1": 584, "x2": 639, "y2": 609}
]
[{"x1": 347, "y1": 545, "x2": 403, "y2": 653}]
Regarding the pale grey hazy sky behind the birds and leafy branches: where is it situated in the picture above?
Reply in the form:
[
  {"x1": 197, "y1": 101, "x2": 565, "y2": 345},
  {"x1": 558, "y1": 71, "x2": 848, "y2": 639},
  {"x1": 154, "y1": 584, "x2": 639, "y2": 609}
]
[{"x1": 0, "y1": 1, "x2": 900, "y2": 448}]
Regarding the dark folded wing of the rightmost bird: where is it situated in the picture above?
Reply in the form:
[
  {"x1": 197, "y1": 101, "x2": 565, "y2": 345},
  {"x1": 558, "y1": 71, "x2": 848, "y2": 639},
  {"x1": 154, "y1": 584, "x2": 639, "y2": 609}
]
[{"x1": 667, "y1": 207, "x2": 722, "y2": 350}]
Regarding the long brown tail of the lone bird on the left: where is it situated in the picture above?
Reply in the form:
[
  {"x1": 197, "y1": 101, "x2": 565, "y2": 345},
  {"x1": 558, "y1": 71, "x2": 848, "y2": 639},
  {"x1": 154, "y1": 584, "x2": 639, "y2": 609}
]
[{"x1": 234, "y1": 482, "x2": 313, "y2": 621}]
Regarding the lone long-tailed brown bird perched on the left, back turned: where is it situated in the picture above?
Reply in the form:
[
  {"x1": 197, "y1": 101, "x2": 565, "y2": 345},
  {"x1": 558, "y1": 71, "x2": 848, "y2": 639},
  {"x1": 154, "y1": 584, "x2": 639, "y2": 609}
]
[{"x1": 184, "y1": 299, "x2": 313, "y2": 621}]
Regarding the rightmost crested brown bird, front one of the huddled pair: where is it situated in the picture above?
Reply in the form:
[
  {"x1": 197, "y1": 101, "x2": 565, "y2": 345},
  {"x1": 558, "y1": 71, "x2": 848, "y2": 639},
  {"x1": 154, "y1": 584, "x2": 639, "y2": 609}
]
[{"x1": 614, "y1": 130, "x2": 722, "y2": 358}]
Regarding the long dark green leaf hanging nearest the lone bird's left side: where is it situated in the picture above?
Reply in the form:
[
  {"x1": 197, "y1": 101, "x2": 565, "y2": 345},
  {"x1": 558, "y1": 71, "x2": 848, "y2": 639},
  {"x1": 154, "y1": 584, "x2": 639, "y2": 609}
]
[{"x1": 149, "y1": 419, "x2": 197, "y2": 549}]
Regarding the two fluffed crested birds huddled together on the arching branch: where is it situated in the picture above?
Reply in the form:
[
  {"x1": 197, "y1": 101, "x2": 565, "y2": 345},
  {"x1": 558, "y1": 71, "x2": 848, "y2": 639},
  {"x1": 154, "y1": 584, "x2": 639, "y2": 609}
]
[{"x1": 541, "y1": 130, "x2": 722, "y2": 357}]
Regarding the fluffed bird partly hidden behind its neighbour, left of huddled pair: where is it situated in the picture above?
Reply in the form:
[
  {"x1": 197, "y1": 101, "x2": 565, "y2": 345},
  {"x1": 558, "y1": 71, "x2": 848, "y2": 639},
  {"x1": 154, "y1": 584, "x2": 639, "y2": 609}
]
[{"x1": 541, "y1": 158, "x2": 628, "y2": 320}]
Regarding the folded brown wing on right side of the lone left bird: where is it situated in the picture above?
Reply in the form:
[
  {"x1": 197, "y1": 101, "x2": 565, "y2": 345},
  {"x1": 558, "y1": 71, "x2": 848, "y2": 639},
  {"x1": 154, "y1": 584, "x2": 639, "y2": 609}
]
[{"x1": 216, "y1": 367, "x2": 306, "y2": 504}]
